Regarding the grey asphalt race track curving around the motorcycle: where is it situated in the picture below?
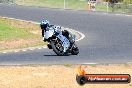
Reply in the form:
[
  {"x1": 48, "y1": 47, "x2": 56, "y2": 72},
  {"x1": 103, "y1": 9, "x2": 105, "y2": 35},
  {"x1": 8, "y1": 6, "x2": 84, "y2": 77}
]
[{"x1": 0, "y1": 4, "x2": 132, "y2": 65}]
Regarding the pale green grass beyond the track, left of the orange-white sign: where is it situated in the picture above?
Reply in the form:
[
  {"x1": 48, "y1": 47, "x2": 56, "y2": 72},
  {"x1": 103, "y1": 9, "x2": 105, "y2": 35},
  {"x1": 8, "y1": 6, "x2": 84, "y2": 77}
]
[{"x1": 16, "y1": 0, "x2": 87, "y2": 9}]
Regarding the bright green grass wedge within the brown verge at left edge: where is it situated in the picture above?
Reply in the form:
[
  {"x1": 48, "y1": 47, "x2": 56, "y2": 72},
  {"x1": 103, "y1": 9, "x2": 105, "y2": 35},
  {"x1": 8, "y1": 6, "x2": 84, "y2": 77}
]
[{"x1": 0, "y1": 23, "x2": 36, "y2": 41}]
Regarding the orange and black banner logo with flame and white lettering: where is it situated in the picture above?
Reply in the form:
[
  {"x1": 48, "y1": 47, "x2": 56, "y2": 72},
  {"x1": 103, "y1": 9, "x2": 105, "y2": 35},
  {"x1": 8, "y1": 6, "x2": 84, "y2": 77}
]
[{"x1": 76, "y1": 65, "x2": 131, "y2": 85}]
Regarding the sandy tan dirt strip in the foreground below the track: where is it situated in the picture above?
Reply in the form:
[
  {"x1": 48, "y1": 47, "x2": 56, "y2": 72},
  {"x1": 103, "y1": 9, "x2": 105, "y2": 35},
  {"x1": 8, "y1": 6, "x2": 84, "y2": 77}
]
[{"x1": 0, "y1": 64, "x2": 132, "y2": 88}]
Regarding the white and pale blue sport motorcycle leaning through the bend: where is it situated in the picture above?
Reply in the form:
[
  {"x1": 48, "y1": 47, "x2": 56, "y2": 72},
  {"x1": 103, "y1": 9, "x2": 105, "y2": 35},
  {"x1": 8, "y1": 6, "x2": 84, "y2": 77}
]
[{"x1": 44, "y1": 25, "x2": 79, "y2": 56}]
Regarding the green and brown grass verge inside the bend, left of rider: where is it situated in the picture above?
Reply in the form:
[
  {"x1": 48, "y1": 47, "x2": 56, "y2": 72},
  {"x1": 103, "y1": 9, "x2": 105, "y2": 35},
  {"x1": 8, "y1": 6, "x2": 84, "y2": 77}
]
[{"x1": 0, "y1": 17, "x2": 46, "y2": 51}]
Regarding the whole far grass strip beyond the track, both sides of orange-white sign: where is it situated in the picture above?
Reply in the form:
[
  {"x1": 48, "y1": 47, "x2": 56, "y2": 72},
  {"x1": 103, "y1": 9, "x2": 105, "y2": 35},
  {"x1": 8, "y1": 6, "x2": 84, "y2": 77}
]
[{"x1": 16, "y1": 0, "x2": 132, "y2": 13}]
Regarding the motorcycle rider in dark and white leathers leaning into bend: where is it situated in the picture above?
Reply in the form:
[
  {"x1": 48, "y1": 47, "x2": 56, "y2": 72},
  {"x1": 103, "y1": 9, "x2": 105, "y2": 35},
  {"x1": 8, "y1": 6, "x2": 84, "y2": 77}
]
[{"x1": 40, "y1": 20, "x2": 74, "y2": 45}]
